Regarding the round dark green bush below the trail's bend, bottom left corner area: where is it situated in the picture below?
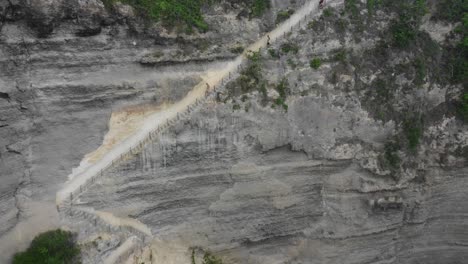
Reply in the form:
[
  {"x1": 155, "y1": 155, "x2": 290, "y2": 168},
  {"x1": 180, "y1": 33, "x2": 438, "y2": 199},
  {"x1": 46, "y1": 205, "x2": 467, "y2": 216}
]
[{"x1": 13, "y1": 229, "x2": 80, "y2": 264}]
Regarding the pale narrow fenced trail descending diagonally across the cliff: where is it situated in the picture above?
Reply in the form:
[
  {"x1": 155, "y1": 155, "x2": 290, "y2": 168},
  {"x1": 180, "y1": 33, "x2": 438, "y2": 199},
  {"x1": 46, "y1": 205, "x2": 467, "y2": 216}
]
[{"x1": 56, "y1": 0, "x2": 343, "y2": 260}]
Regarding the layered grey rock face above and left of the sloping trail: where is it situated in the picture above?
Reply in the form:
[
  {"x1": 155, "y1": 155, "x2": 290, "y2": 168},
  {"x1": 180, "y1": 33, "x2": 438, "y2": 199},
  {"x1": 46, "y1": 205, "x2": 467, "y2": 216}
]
[{"x1": 0, "y1": 0, "x2": 284, "y2": 263}]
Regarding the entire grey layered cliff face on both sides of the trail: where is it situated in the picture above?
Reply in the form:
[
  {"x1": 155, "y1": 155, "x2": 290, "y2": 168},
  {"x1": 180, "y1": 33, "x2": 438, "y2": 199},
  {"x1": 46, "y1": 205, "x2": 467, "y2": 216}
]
[{"x1": 0, "y1": 0, "x2": 468, "y2": 264}]
